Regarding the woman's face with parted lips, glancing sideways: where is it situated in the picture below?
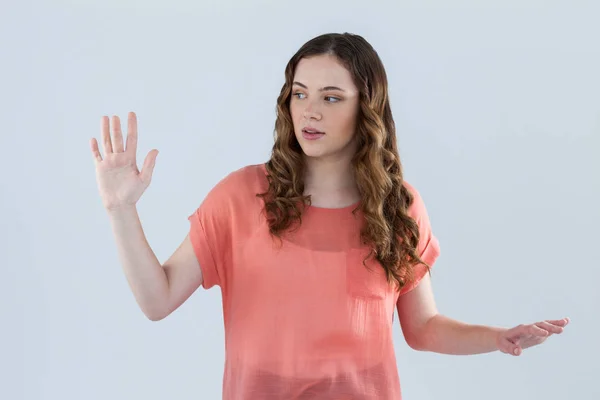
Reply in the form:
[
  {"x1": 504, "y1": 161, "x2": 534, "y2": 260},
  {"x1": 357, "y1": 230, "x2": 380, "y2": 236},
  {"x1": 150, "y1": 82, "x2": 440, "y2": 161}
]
[{"x1": 290, "y1": 55, "x2": 359, "y2": 161}]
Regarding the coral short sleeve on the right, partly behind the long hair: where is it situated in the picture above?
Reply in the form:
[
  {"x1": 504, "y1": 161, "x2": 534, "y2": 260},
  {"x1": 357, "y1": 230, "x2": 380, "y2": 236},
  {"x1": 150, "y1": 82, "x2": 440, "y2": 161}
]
[{"x1": 400, "y1": 184, "x2": 440, "y2": 296}]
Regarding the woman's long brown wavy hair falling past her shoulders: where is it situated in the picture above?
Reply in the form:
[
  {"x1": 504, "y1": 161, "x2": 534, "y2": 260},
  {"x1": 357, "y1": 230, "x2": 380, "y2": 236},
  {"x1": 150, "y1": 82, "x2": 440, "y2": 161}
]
[{"x1": 257, "y1": 33, "x2": 430, "y2": 290}]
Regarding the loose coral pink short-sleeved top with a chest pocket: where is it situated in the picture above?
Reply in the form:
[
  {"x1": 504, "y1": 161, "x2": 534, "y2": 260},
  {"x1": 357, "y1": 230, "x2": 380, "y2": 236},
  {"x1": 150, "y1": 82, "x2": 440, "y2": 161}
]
[{"x1": 189, "y1": 164, "x2": 439, "y2": 400}]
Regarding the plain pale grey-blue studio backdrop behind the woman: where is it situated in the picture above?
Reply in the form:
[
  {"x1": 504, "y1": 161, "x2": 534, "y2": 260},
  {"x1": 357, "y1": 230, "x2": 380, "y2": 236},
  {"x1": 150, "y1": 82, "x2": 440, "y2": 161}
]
[{"x1": 0, "y1": 0, "x2": 600, "y2": 400}]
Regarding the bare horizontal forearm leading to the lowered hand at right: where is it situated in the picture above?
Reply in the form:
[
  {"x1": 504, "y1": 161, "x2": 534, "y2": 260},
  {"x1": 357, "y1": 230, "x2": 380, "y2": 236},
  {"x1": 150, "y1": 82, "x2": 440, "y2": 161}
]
[{"x1": 415, "y1": 314, "x2": 506, "y2": 355}]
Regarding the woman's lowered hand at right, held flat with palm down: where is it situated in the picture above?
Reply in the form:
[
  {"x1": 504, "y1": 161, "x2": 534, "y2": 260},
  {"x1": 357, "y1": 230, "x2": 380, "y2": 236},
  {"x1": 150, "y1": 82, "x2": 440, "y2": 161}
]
[{"x1": 496, "y1": 318, "x2": 570, "y2": 356}]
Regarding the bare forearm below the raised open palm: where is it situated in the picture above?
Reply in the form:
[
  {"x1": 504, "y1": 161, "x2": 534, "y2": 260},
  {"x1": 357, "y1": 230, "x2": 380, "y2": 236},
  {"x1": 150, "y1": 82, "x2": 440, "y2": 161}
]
[{"x1": 108, "y1": 206, "x2": 169, "y2": 320}]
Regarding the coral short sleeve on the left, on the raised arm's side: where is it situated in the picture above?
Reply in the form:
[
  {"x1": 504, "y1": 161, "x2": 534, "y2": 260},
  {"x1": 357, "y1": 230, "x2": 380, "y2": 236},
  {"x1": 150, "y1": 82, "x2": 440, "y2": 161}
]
[{"x1": 188, "y1": 179, "x2": 231, "y2": 289}]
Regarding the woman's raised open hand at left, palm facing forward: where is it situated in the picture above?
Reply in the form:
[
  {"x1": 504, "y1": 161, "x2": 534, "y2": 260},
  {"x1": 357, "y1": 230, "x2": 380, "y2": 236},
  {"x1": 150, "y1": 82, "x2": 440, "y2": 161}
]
[{"x1": 90, "y1": 112, "x2": 158, "y2": 211}]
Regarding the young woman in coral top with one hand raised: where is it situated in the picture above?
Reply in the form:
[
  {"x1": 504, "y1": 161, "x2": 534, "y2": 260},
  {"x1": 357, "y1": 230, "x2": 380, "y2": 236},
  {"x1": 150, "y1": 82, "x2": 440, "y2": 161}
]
[{"x1": 91, "y1": 34, "x2": 569, "y2": 400}]
